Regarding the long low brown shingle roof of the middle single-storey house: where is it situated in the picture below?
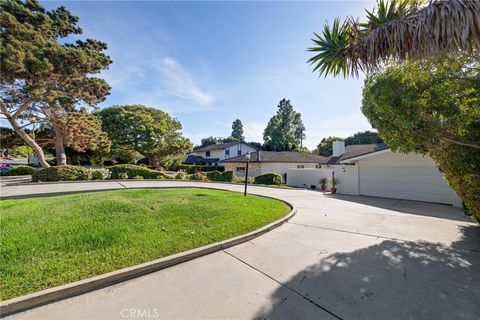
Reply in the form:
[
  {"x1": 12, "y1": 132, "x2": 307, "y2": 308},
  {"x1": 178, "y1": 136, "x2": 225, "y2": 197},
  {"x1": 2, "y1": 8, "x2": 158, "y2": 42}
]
[{"x1": 220, "y1": 151, "x2": 326, "y2": 163}]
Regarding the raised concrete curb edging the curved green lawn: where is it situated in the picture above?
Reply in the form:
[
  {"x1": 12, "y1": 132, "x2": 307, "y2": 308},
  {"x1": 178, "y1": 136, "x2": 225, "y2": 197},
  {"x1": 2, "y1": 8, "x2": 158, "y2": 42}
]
[{"x1": 0, "y1": 191, "x2": 297, "y2": 318}]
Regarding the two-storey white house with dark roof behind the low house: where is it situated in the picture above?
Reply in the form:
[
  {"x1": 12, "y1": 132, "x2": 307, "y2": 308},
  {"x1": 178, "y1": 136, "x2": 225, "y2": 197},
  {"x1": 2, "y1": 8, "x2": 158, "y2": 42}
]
[{"x1": 183, "y1": 141, "x2": 257, "y2": 166}]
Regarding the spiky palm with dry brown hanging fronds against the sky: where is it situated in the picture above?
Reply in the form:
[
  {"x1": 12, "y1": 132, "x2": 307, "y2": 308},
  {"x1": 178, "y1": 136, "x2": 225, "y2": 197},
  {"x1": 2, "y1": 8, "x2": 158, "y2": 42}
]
[{"x1": 308, "y1": 0, "x2": 480, "y2": 77}]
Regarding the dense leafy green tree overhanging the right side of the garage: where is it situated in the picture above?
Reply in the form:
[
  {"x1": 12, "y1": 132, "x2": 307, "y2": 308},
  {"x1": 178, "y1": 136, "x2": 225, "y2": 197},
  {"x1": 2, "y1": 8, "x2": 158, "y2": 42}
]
[{"x1": 362, "y1": 54, "x2": 480, "y2": 220}]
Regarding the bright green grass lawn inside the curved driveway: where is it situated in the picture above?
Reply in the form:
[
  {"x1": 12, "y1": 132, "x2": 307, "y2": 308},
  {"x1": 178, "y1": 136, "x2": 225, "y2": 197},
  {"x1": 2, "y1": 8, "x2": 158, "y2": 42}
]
[{"x1": 0, "y1": 188, "x2": 290, "y2": 300}]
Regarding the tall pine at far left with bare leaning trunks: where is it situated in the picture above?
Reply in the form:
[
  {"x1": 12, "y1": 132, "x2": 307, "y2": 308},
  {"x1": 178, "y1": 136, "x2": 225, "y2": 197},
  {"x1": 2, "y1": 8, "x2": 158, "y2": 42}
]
[{"x1": 0, "y1": 0, "x2": 111, "y2": 167}]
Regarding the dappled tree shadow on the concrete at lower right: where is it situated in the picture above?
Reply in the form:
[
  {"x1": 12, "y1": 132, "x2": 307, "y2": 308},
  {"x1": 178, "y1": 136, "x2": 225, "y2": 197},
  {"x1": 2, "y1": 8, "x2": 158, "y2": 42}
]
[{"x1": 256, "y1": 226, "x2": 480, "y2": 320}]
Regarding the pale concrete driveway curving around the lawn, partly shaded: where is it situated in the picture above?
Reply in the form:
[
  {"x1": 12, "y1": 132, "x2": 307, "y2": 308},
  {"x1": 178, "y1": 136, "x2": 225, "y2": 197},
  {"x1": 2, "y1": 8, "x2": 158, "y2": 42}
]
[{"x1": 2, "y1": 181, "x2": 480, "y2": 320}]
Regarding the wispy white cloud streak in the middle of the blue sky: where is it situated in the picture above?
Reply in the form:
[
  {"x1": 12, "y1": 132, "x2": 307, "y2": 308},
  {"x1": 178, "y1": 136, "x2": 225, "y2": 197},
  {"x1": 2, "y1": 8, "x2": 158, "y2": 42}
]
[{"x1": 157, "y1": 57, "x2": 214, "y2": 106}]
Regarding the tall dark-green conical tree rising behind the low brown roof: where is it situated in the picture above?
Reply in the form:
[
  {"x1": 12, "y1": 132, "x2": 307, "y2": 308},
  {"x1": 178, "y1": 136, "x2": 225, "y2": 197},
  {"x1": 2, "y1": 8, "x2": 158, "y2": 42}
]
[{"x1": 263, "y1": 99, "x2": 305, "y2": 151}]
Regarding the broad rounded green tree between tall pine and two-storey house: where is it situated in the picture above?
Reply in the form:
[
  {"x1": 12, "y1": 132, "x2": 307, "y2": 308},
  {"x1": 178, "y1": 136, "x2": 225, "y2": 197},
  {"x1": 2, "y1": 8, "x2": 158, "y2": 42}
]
[{"x1": 97, "y1": 105, "x2": 192, "y2": 168}]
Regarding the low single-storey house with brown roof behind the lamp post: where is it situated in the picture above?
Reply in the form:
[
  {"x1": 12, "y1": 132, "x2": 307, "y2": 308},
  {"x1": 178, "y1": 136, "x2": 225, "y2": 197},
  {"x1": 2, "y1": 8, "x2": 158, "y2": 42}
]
[{"x1": 221, "y1": 151, "x2": 326, "y2": 179}]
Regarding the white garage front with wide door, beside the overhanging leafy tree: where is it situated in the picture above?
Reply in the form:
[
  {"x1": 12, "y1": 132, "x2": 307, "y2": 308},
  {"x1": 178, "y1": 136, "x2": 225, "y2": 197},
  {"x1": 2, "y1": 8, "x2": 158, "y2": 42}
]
[{"x1": 358, "y1": 152, "x2": 457, "y2": 204}]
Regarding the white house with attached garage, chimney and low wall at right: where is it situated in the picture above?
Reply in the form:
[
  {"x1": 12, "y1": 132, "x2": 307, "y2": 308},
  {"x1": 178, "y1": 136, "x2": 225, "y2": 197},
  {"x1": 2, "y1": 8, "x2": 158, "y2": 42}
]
[{"x1": 287, "y1": 141, "x2": 461, "y2": 206}]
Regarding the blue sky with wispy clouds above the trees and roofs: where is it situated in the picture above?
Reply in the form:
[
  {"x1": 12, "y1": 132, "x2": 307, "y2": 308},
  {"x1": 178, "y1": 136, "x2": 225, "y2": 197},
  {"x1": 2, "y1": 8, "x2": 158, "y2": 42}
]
[{"x1": 42, "y1": 0, "x2": 373, "y2": 149}]
